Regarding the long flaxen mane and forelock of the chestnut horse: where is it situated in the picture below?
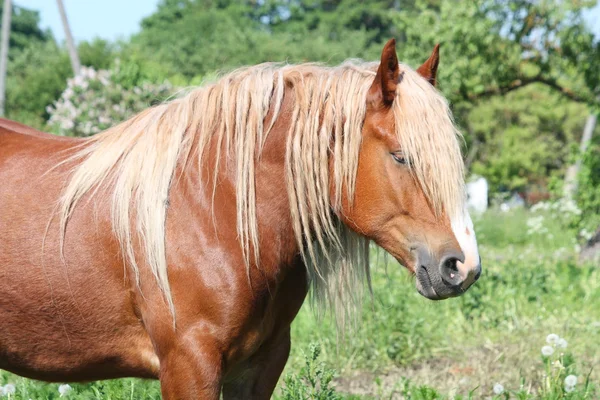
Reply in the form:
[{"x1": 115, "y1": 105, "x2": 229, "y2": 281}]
[{"x1": 58, "y1": 61, "x2": 464, "y2": 322}]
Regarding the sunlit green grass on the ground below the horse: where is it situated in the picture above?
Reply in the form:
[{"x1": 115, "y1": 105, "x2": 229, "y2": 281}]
[{"x1": 0, "y1": 210, "x2": 600, "y2": 400}]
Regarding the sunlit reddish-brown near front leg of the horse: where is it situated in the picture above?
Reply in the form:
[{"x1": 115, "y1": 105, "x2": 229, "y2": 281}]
[{"x1": 160, "y1": 336, "x2": 223, "y2": 400}]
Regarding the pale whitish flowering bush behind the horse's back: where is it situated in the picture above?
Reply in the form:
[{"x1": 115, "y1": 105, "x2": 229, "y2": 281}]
[{"x1": 47, "y1": 67, "x2": 172, "y2": 136}]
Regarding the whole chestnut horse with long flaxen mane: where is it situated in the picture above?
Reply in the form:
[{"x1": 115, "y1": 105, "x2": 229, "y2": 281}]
[{"x1": 0, "y1": 39, "x2": 481, "y2": 399}]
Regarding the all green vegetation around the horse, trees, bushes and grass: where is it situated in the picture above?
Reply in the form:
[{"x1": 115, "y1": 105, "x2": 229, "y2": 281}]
[{"x1": 0, "y1": 0, "x2": 600, "y2": 399}]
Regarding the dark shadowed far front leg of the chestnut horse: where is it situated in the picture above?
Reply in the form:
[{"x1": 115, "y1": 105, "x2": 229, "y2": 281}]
[{"x1": 223, "y1": 328, "x2": 291, "y2": 400}]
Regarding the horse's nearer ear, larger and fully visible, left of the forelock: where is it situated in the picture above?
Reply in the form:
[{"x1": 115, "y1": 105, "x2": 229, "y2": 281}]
[{"x1": 368, "y1": 39, "x2": 400, "y2": 107}]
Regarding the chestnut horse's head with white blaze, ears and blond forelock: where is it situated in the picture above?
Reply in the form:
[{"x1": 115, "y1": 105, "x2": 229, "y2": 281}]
[{"x1": 337, "y1": 40, "x2": 481, "y2": 300}]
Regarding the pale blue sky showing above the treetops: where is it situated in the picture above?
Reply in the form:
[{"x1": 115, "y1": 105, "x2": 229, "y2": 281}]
[{"x1": 13, "y1": 0, "x2": 600, "y2": 42}]
